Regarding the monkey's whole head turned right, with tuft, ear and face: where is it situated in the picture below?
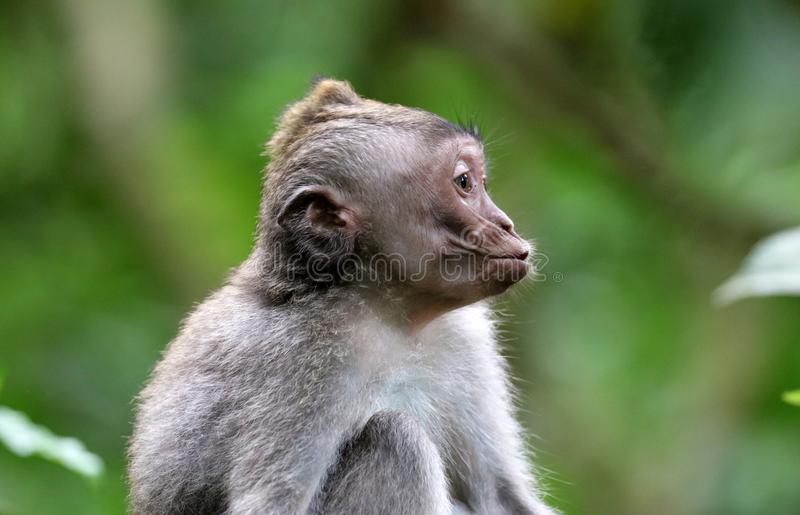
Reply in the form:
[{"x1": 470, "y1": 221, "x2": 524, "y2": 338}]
[{"x1": 257, "y1": 80, "x2": 531, "y2": 321}]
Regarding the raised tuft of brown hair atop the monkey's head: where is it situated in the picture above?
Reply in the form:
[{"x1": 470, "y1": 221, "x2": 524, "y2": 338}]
[{"x1": 267, "y1": 77, "x2": 361, "y2": 158}]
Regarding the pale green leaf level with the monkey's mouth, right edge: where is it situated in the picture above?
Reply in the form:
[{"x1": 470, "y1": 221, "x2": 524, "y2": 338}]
[{"x1": 714, "y1": 227, "x2": 800, "y2": 304}]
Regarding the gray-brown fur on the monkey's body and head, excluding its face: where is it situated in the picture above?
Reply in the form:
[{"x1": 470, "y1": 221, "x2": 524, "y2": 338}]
[{"x1": 129, "y1": 81, "x2": 553, "y2": 515}]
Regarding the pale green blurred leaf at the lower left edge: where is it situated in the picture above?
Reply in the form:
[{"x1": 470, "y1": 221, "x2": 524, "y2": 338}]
[{"x1": 0, "y1": 406, "x2": 103, "y2": 478}]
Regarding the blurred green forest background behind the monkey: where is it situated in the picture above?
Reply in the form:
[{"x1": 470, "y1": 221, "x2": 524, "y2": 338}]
[{"x1": 0, "y1": 0, "x2": 800, "y2": 515}]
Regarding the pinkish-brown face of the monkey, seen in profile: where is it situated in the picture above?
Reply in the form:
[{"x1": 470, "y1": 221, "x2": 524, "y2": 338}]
[{"x1": 387, "y1": 135, "x2": 531, "y2": 305}]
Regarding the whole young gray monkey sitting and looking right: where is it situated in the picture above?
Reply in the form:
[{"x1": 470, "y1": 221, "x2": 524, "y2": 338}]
[{"x1": 128, "y1": 79, "x2": 556, "y2": 515}]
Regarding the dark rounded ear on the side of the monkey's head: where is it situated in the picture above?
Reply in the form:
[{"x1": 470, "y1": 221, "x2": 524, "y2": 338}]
[{"x1": 277, "y1": 185, "x2": 358, "y2": 233}]
